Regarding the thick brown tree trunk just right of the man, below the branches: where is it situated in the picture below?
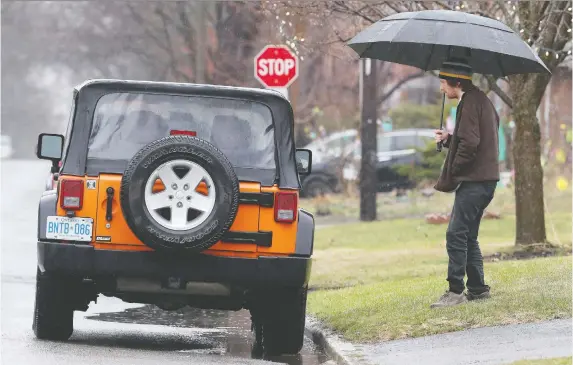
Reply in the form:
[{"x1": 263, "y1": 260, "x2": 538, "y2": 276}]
[{"x1": 510, "y1": 74, "x2": 549, "y2": 245}]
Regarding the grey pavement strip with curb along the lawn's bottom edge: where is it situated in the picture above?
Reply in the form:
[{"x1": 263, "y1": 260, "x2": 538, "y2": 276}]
[{"x1": 309, "y1": 318, "x2": 573, "y2": 365}]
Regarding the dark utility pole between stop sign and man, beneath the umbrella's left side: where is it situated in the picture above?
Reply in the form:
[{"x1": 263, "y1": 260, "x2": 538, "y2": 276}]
[{"x1": 359, "y1": 58, "x2": 378, "y2": 221}]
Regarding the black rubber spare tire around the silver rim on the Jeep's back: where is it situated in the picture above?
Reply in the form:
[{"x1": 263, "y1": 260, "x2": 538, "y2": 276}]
[{"x1": 120, "y1": 136, "x2": 239, "y2": 253}]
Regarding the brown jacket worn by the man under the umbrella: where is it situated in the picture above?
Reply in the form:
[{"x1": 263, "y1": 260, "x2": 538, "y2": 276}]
[{"x1": 434, "y1": 85, "x2": 499, "y2": 192}]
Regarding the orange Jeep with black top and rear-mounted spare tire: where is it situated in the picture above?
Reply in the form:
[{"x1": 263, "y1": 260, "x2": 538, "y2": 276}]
[{"x1": 33, "y1": 80, "x2": 314, "y2": 354}]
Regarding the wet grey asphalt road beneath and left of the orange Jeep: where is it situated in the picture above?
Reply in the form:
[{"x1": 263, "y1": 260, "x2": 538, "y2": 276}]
[{"x1": 0, "y1": 160, "x2": 328, "y2": 365}]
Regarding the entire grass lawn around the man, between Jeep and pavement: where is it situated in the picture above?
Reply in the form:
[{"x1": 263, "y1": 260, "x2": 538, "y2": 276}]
[{"x1": 308, "y1": 189, "x2": 572, "y2": 342}]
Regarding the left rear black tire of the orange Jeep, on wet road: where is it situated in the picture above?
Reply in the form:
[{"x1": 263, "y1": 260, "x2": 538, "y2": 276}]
[{"x1": 32, "y1": 270, "x2": 74, "y2": 341}]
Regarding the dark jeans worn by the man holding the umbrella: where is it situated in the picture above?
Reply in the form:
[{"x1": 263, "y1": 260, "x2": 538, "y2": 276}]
[{"x1": 446, "y1": 181, "x2": 497, "y2": 294}]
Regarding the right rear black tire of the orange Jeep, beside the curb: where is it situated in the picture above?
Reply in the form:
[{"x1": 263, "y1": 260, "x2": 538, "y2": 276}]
[{"x1": 251, "y1": 287, "x2": 308, "y2": 356}]
